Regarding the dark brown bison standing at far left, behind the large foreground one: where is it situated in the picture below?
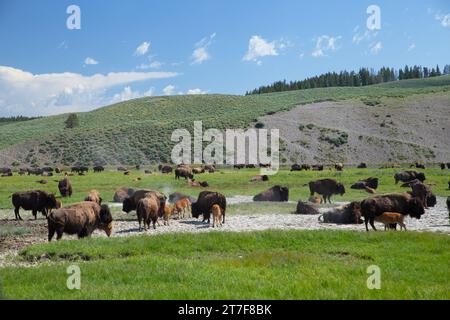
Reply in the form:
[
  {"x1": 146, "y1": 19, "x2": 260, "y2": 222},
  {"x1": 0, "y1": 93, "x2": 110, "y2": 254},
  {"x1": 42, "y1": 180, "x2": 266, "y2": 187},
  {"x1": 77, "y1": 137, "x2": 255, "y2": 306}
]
[{"x1": 12, "y1": 190, "x2": 61, "y2": 220}]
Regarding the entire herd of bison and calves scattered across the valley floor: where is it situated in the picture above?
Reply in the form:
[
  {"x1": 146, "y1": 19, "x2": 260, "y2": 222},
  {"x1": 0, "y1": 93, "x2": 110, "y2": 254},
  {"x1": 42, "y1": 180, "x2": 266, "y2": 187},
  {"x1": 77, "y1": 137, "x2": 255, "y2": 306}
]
[{"x1": 4, "y1": 163, "x2": 450, "y2": 241}]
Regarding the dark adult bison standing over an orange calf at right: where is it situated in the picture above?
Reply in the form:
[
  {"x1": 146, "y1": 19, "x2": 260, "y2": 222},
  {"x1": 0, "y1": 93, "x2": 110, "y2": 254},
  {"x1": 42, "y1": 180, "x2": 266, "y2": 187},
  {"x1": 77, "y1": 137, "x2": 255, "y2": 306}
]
[{"x1": 361, "y1": 192, "x2": 425, "y2": 231}]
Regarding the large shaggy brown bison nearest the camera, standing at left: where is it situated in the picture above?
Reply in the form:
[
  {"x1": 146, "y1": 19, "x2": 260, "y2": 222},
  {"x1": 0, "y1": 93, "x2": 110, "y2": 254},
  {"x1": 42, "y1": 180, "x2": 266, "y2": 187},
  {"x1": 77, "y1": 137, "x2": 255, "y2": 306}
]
[{"x1": 47, "y1": 202, "x2": 113, "y2": 242}]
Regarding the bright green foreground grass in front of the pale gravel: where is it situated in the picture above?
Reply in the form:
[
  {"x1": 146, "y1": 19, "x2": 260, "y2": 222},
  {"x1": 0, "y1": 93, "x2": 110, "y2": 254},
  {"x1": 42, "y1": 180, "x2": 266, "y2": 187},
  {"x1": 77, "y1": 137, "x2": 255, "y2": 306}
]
[{"x1": 0, "y1": 231, "x2": 450, "y2": 299}]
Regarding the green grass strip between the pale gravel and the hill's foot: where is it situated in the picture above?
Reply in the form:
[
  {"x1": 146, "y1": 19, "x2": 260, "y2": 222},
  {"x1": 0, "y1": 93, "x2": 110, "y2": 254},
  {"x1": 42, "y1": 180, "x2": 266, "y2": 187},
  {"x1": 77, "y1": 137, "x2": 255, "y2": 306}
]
[{"x1": 0, "y1": 168, "x2": 450, "y2": 210}]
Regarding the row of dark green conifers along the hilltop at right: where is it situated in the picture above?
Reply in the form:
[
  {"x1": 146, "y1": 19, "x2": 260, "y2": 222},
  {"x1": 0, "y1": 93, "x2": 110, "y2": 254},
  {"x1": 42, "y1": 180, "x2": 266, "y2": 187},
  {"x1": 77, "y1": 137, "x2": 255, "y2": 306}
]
[{"x1": 245, "y1": 64, "x2": 450, "y2": 95}]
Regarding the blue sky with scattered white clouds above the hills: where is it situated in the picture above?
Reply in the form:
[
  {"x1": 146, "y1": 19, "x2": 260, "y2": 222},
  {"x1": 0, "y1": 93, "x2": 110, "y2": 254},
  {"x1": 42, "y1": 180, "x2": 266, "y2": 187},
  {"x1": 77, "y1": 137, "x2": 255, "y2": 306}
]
[{"x1": 0, "y1": 0, "x2": 450, "y2": 116}]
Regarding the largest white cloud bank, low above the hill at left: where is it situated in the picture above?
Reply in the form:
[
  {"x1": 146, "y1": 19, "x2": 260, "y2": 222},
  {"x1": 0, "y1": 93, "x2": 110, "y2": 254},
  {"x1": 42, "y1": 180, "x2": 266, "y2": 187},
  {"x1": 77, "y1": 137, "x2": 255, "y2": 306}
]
[{"x1": 0, "y1": 66, "x2": 177, "y2": 115}]
